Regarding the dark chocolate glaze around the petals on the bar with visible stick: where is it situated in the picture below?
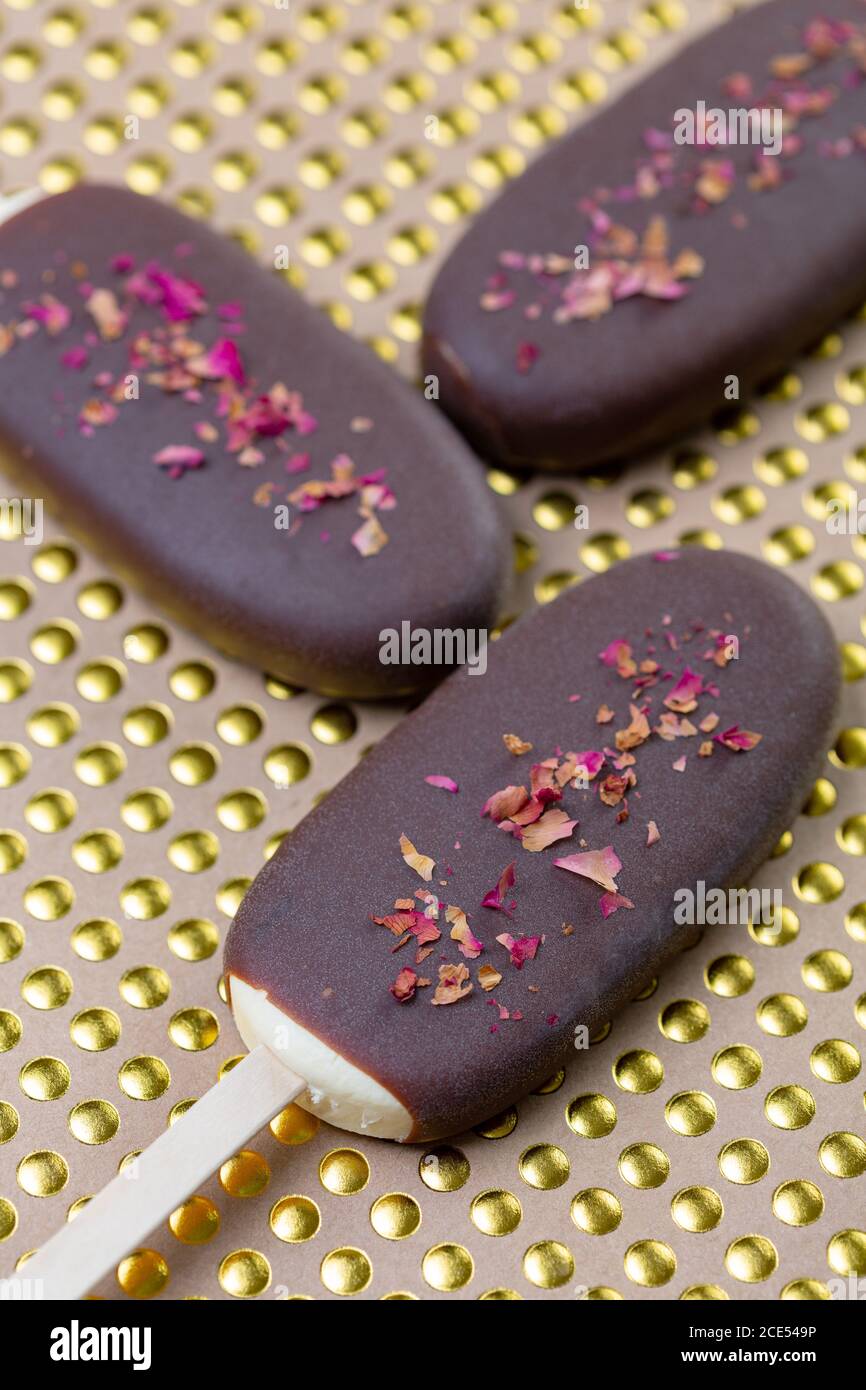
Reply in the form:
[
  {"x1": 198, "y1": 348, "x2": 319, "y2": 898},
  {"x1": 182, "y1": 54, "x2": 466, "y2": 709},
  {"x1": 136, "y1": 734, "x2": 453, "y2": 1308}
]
[{"x1": 225, "y1": 550, "x2": 840, "y2": 1140}]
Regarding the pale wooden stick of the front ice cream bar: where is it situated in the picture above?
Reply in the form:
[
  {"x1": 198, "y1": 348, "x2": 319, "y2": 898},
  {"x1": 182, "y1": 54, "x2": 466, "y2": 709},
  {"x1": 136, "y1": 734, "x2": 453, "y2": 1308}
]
[{"x1": 14, "y1": 1047, "x2": 307, "y2": 1300}]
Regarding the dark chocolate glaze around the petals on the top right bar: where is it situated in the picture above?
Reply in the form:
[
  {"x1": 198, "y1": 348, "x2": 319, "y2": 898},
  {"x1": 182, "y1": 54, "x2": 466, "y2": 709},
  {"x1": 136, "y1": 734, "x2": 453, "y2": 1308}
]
[{"x1": 423, "y1": 0, "x2": 866, "y2": 470}]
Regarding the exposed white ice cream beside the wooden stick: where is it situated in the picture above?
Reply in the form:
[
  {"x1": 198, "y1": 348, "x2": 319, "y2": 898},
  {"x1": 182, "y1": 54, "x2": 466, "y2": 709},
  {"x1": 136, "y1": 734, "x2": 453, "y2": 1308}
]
[{"x1": 231, "y1": 976, "x2": 413, "y2": 1140}]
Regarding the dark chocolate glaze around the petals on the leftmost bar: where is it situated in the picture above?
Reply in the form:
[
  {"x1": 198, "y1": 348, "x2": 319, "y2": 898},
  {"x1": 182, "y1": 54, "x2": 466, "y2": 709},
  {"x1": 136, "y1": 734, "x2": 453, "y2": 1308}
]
[{"x1": 0, "y1": 185, "x2": 507, "y2": 696}]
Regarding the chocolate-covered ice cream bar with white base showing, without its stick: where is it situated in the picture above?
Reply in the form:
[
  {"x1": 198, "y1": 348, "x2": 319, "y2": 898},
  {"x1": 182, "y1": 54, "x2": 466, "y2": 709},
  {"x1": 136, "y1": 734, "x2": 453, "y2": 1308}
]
[{"x1": 225, "y1": 550, "x2": 840, "y2": 1141}]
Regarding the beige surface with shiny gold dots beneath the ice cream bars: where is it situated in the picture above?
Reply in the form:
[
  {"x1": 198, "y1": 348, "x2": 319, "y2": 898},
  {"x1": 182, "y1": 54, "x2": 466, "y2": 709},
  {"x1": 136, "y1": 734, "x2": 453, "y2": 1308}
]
[{"x1": 0, "y1": 0, "x2": 866, "y2": 1300}]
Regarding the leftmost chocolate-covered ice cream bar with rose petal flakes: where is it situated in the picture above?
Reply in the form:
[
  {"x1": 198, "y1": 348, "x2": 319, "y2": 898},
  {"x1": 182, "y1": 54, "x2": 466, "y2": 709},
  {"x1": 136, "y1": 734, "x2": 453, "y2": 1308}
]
[{"x1": 0, "y1": 185, "x2": 506, "y2": 696}]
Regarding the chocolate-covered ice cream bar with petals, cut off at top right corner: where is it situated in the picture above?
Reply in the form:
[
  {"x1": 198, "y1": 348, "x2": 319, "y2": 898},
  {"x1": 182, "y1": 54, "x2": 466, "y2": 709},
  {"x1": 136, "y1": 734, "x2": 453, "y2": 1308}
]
[{"x1": 424, "y1": 0, "x2": 866, "y2": 470}]
